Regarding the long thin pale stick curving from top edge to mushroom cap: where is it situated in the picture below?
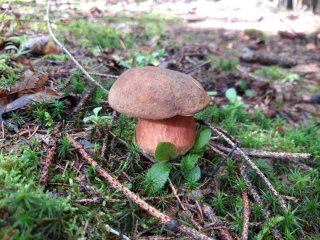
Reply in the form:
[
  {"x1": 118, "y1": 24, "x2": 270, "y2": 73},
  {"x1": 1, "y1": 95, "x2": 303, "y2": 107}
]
[{"x1": 46, "y1": 0, "x2": 109, "y2": 93}]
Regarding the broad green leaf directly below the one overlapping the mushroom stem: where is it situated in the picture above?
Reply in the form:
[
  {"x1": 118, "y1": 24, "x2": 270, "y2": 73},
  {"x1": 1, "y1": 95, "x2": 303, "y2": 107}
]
[{"x1": 144, "y1": 161, "x2": 171, "y2": 194}]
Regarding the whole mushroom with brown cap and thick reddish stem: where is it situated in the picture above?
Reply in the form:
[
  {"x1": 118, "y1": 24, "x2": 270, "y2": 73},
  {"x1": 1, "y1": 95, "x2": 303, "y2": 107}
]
[{"x1": 109, "y1": 66, "x2": 210, "y2": 155}]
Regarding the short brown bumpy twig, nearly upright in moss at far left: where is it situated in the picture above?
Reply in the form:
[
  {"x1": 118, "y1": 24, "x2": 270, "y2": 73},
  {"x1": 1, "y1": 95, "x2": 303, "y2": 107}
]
[{"x1": 39, "y1": 123, "x2": 61, "y2": 186}]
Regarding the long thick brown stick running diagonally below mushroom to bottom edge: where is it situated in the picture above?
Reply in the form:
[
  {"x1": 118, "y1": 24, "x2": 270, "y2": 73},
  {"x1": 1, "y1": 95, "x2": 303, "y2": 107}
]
[{"x1": 67, "y1": 134, "x2": 212, "y2": 240}]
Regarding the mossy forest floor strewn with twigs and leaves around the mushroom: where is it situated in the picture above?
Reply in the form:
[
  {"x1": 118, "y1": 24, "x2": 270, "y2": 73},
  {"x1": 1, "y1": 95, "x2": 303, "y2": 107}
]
[{"x1": 0, "y1": 1, "x2": 320, "y2": 240}]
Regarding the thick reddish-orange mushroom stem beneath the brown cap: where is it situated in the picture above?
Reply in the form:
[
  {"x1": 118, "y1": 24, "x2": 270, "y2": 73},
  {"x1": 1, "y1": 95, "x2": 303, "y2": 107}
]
[{"x1": 136, "y1": 116, "x2": 197, "y2": 155}]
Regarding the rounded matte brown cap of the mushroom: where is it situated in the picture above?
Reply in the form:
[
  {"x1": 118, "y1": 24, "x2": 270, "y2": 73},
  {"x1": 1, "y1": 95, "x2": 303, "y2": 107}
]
[{"x1": 109, "y1": 67, "x2": 210, "y2": 119}]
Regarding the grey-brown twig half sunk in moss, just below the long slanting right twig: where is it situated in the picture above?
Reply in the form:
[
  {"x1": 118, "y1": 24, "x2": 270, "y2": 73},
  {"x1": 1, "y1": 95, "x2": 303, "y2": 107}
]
[{"x1": 240, "y1": 164, "x2": 283, "y2": 240}]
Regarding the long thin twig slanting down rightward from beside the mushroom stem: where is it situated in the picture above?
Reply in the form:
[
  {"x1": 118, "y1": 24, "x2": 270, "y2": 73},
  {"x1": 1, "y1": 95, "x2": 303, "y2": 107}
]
[{"x1": 206, "y1": 123, "x2": 288, "y2": 210}]
